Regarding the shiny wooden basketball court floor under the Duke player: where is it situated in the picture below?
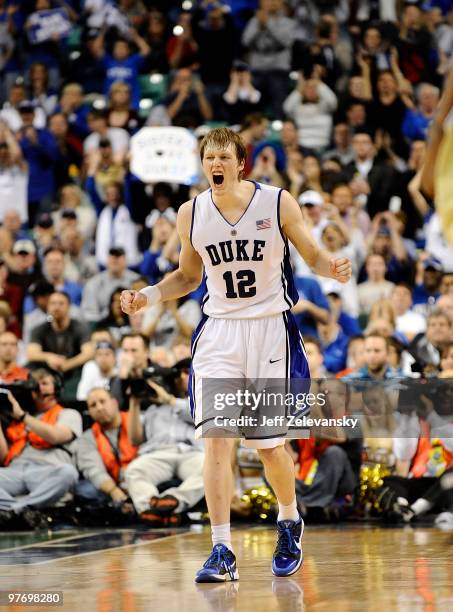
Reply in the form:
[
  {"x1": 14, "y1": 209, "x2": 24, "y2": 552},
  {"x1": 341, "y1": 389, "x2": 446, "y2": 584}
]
[{"x1": 0, "y1": 525, "x2": 453, "y2": 612}]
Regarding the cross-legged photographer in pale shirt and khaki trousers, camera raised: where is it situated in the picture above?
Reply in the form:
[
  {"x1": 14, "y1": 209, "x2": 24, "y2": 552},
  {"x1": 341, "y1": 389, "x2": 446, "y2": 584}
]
[{"x1": 122, "y1": 359, "x2": 204, "y2": 525}]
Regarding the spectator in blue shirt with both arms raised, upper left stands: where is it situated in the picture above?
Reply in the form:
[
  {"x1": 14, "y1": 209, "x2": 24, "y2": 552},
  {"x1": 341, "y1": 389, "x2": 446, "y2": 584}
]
[{"x1": 93, "y1": 29, "x2": 150, "y2": 110}]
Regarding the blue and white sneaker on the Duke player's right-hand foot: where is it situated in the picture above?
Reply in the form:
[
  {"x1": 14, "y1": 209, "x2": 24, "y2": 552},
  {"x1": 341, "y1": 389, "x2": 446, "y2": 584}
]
[{"x1": 272, "y1": 517, "x2": 304, "y2": 576}]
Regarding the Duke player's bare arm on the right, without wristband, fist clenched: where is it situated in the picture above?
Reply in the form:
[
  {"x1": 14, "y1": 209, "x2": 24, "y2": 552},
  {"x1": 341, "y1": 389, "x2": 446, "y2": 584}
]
[{"x1": 280, "y1": 191, "x2": 352, "y2": 283}]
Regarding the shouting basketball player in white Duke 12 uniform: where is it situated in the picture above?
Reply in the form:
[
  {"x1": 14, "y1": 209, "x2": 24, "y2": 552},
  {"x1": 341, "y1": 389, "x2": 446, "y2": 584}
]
[{"x1": 121, "y1": 128, "x2": 351, "y2": 582}]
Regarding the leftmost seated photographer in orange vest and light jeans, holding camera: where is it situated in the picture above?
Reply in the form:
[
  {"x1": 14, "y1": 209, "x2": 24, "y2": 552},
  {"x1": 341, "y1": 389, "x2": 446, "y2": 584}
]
[{"x1": 0, "y1": 369, "x2": 82, "y2": 527}]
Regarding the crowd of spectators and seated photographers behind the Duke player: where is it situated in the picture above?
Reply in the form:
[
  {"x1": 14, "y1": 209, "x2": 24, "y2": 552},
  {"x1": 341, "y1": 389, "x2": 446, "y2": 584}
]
[{"x1": 0, "y1": 0, "x2": 453, "y2": 525}]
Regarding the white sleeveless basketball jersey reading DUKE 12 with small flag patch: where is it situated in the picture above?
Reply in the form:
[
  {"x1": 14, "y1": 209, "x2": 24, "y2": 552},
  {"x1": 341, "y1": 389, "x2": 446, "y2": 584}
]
[{"x1": 190, "y1": 183, "x2": 297, "y2": 319}]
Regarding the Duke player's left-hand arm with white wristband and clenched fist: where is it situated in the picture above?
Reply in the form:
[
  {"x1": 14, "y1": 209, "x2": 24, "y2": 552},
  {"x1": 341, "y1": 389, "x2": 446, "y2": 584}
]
[{"x1": 121, "y1": 201, "x2": 203, "y2": 314}]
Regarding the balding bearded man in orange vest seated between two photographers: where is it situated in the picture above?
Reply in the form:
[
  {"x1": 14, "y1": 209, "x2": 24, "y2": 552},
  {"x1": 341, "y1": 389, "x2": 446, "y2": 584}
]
[{"x1": 75, "y1": 387, "x2": 137, "y2": 513}]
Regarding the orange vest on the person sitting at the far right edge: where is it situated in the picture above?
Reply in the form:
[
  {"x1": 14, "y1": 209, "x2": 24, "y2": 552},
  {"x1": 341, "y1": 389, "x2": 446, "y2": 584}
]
[{"x1": 410, "y1": 419, "x2": 453, "y2": 478}]
